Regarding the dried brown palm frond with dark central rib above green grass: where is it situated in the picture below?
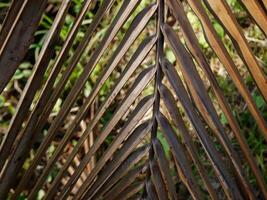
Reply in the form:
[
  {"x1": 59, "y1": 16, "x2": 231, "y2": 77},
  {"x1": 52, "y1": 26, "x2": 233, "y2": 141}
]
[{"x1": 0, "y1": 0, "x2": 267, "y2": 200}]
